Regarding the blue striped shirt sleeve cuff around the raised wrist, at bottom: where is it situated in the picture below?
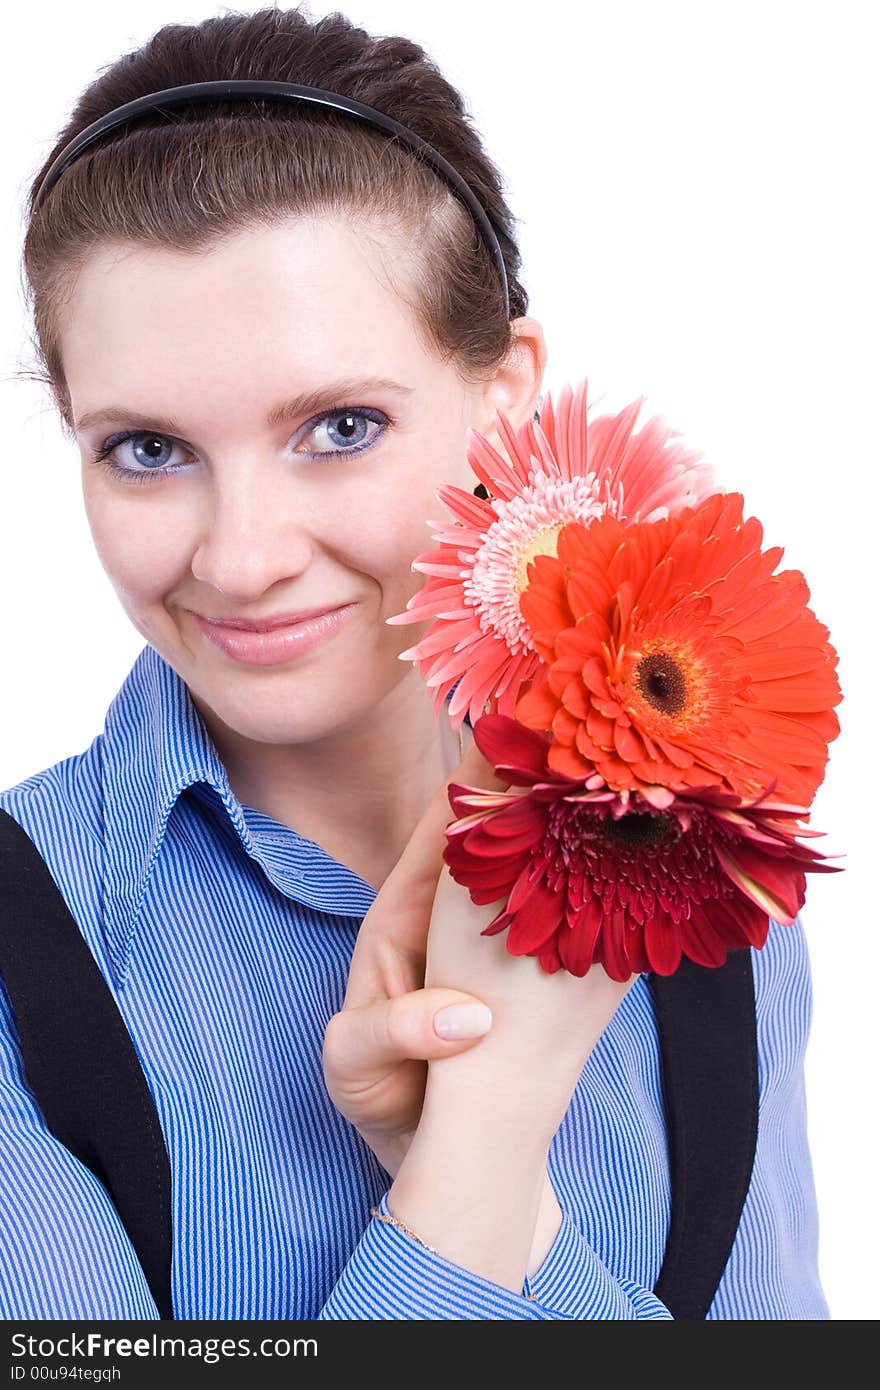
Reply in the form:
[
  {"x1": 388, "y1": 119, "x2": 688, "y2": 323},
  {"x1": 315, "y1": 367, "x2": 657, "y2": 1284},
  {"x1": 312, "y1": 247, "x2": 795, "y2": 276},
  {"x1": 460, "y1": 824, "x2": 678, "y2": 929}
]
[{"x1": 318, "y1": 1193, "x2": 670, "y2": 1322}]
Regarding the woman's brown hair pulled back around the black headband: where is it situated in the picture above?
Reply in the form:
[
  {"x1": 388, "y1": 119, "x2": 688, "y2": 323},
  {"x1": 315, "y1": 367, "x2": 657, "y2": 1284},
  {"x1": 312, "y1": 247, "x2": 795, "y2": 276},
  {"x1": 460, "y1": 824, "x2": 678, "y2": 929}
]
[{"x1": 22, "y1": 8, "x2": 528, "y2": 432}]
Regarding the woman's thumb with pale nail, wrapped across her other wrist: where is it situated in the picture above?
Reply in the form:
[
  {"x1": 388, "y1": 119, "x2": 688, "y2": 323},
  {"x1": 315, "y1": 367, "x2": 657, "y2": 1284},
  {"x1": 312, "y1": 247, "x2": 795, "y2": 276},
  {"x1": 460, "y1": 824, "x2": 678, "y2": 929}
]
[{"x1": 324, "y1": 987, "x2": 492, "y2": 1087}]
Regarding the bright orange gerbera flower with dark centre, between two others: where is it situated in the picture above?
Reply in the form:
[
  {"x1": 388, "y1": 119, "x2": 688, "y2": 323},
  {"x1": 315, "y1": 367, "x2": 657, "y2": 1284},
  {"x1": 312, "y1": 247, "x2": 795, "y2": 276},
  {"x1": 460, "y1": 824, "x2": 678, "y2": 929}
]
[{"x1": 516, "y1": 493, "x2": 842, "y2": 806}]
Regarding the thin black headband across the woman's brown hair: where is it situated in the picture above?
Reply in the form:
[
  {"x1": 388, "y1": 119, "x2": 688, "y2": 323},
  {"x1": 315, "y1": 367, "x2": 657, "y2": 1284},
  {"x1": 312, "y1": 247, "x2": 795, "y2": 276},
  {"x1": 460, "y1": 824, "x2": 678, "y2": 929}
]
[{"x1": 35, "y1": 79, "x2": 510, "y2": 317}]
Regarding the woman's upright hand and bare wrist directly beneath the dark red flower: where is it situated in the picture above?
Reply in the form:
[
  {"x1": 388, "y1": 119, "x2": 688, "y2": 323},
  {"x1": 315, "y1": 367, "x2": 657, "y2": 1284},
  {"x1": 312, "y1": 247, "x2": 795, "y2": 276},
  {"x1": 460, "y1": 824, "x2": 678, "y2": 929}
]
[{"x1": 388, "y1": 834, "x2": 637, "y2": 1293}]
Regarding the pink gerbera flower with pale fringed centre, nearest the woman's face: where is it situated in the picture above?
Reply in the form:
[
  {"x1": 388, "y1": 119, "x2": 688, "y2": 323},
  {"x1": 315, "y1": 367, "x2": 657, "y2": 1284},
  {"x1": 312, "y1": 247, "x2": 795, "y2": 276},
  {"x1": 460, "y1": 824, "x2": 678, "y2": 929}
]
[{"x1": 386, "y1": 381, "x2": 717, "y2": 726}]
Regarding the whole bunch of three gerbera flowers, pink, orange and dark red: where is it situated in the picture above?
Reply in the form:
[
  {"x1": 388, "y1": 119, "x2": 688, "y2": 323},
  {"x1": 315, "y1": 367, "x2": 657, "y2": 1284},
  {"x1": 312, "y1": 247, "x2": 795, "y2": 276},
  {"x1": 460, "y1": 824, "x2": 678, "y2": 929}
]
[{"x1": 388, "y1": 382, "x2": 842, "y2": 980}]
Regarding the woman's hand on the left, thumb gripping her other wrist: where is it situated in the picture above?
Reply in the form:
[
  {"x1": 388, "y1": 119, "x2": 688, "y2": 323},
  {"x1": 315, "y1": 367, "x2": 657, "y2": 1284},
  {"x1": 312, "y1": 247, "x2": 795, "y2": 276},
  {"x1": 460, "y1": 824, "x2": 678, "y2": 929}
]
[{"x1": 324, "y1": 742, "x2": 506, "y2": 1176}]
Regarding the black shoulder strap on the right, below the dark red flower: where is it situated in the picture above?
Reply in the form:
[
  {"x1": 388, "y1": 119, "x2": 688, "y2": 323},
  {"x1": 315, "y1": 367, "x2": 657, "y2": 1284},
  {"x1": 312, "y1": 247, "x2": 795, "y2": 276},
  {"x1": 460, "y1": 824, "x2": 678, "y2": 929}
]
[{"x1": 651, "y1": 949, "x2": 758, "y2": 1321}]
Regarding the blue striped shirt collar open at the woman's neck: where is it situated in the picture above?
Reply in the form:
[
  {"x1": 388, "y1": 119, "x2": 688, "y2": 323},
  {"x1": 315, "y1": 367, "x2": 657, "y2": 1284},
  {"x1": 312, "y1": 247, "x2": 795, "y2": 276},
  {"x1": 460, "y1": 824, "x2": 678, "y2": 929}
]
[{"x1": 101, "y1": 645, "x2": 469, "y2": 987}]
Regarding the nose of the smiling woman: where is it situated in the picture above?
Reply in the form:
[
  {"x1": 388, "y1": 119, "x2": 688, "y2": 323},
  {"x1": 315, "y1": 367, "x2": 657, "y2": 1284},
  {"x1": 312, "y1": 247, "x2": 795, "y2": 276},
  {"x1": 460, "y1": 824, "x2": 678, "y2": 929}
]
[{"x1": 192, "y1": 460, "x2": 314, "y2": 603}]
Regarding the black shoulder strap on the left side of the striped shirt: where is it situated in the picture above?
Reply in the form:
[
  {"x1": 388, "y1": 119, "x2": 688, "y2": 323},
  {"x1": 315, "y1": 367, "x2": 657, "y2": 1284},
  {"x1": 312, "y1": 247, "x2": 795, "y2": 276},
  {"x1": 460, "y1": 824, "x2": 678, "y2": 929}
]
[{"x1": 0, "y1": 809, "x2": 174, "y2": 1318}]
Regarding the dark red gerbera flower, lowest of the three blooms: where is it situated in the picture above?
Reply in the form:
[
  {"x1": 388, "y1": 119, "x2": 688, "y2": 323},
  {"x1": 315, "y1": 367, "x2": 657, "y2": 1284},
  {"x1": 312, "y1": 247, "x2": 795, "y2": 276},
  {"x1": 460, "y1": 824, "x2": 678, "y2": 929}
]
[{"x1": 443, "y1": 714, "x2": 838, "y2": 981}]
